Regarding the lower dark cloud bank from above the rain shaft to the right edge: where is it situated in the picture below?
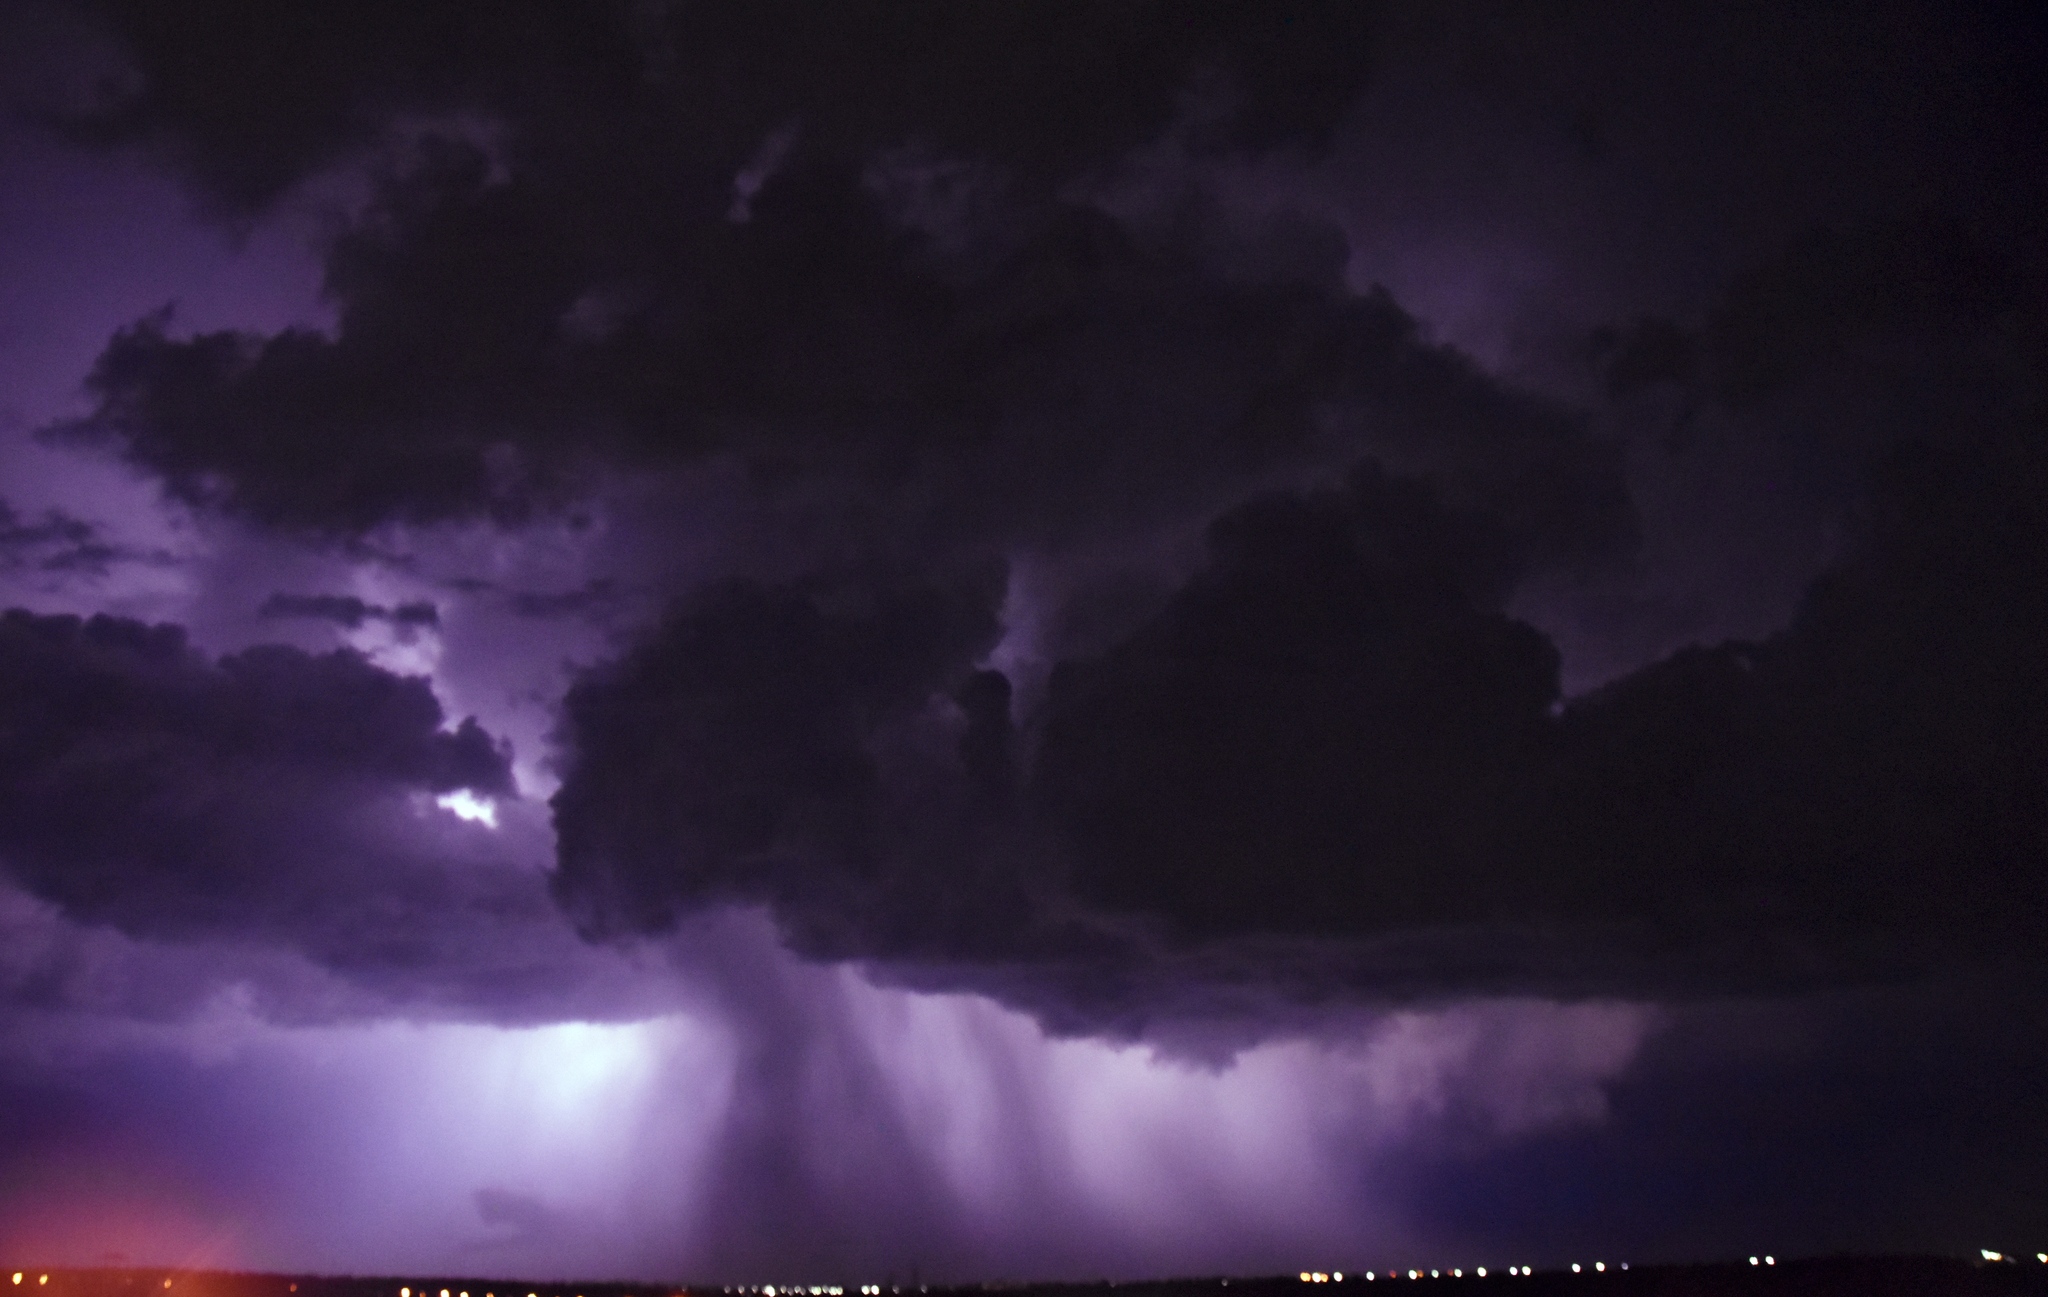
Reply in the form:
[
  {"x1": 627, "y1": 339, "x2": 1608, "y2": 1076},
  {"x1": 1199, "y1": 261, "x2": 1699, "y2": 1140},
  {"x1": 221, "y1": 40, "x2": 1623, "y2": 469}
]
[{"x1": 555, "y1": 366, "x2": 2048, "y2": 1032}]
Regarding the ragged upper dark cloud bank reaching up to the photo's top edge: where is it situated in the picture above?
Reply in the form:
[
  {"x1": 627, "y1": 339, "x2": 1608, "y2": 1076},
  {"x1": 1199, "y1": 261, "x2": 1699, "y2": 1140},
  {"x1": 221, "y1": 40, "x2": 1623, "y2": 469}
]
[{"x1": 39, "y1": 4, "x2": 1628, "y2": 557}]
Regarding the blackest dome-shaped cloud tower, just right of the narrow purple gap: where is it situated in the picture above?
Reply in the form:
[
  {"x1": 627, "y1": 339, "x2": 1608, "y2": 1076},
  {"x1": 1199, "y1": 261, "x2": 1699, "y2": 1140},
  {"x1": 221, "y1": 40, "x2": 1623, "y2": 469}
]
[{"x1": 1034, "y1": 469, "x2": 1559, "y2": 934}]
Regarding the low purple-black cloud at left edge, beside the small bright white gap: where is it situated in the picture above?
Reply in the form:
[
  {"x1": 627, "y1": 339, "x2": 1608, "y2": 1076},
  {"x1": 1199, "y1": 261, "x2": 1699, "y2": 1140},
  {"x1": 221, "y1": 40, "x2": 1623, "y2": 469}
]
[{"x1": 0, "y1": 609, "x2": 520, "y2": 967}]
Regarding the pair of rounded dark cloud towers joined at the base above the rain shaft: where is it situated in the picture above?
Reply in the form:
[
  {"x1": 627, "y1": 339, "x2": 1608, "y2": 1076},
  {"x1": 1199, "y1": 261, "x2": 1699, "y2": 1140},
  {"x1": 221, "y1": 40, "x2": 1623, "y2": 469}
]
[{"x1": 555, "y1": 456, "x2": 1581, "y2": 1032}]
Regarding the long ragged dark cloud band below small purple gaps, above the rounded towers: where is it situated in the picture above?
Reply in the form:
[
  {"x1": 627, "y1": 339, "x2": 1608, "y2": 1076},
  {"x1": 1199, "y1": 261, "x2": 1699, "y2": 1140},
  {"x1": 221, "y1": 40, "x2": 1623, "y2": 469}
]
[{"x1": 53, "y1": 185, "x2": 1632, "y2": 561}]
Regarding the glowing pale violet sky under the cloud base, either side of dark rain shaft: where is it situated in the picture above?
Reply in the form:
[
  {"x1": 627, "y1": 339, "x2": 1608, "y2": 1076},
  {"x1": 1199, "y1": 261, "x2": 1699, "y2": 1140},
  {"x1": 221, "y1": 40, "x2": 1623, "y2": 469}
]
[{"x1": 0, "y1": 913, "x2": 1655, "y2": 1281}]
